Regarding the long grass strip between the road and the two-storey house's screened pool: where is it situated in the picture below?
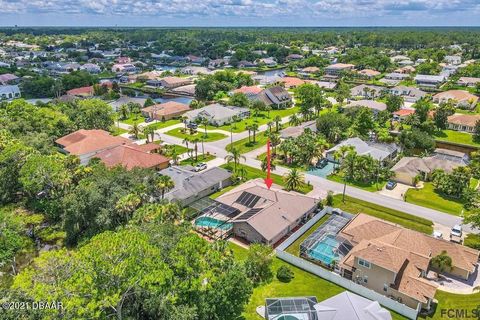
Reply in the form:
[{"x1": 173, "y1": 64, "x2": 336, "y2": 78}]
[{"x1": 332, "y1": 194, "x2": 433, "y2": 234}]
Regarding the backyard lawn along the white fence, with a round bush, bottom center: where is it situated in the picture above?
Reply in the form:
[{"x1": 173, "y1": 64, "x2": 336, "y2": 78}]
[{"x1": 229, "y1": 242, "x2": 405, "y2": 320}]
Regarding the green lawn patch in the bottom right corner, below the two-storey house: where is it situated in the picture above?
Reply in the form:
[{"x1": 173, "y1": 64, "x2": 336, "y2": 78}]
[{"x1": 419, "y1": 290, "x2": 480, "y2": 320}]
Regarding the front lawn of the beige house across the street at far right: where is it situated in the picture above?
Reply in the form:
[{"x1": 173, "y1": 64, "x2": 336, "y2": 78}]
[{"x1": 406, "y1": 182, "x2": 463, "y2": 216}]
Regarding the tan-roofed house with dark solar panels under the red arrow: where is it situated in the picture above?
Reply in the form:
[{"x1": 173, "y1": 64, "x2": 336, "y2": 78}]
[{"x1": 216, "y1": 179, "x2": 318, "y2": 245}]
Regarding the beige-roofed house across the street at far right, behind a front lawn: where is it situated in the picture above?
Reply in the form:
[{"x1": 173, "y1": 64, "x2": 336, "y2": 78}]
[{"x1": 391, "y1": 149, "x2": 468, "y2": 185}]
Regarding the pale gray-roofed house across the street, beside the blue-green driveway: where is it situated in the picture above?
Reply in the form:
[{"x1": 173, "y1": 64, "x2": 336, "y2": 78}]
[{"x1": 325, "y1": 137, "x2": 400, "y2": 162}]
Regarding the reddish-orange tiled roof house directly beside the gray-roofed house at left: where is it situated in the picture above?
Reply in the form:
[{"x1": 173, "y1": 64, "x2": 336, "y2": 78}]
[{"x1": 94, "y1": 143, "x2": 170, "y2": 170}]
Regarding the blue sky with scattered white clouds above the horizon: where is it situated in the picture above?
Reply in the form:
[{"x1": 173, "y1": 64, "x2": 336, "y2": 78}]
[{"x1": 0, "y1": 0, "x2": 480, "y2": 26}]
